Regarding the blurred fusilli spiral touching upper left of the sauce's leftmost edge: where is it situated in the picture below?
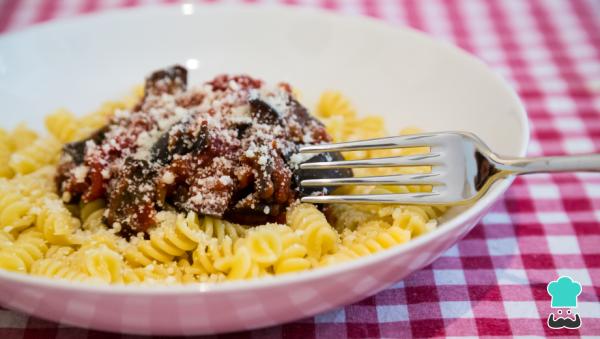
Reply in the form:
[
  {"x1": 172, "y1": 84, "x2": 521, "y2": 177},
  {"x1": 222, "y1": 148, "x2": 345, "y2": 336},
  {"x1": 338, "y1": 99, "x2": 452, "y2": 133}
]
[{"x1": 8, "y1": 137, "x2": 62, "y2": 174}]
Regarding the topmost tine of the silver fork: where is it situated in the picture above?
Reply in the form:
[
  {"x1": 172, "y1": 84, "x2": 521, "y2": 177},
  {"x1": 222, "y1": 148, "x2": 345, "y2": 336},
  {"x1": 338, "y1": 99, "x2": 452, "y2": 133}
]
[{"x1": 300, "y1": 133, "x2": 439, "y2": 153}]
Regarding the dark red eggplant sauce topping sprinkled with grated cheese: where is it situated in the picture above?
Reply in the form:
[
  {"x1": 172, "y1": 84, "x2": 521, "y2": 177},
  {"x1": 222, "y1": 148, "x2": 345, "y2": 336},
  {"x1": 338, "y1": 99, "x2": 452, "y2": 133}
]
[{"x1": 56, "y1": 66, "x2": 352, "y2": 236}]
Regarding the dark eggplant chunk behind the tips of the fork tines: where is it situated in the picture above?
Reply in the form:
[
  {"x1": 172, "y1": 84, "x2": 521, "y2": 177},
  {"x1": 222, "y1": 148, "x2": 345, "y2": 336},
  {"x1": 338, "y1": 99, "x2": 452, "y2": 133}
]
[{"x1": 294, "y1": 152, "x2": 353, "y2": 196}]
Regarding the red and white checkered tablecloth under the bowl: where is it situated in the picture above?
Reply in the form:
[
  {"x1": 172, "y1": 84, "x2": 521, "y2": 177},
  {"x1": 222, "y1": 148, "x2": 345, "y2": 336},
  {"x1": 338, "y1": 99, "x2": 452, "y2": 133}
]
[{"x1": 0, "y1": 0, "x2": 600, "y2": 338}]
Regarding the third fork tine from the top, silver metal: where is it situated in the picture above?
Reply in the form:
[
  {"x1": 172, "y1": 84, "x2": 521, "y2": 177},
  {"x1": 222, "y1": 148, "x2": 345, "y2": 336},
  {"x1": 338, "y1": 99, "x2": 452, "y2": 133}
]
[{"x1": 300, "y1": 173, "x2": 441, "y2": 187}]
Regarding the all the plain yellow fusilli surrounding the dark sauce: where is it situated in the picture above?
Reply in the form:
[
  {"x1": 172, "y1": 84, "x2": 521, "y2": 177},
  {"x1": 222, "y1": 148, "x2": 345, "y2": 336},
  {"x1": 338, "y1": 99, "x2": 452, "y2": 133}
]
[{"x1": 0, "y1": 87, "x2": 445, "y2": 284}]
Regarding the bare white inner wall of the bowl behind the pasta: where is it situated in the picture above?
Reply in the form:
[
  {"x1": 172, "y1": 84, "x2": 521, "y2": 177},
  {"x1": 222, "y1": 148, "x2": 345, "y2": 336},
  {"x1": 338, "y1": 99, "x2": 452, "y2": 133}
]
[{"x1": 0, "y1": 6, "x2": 528, "y2": 290}]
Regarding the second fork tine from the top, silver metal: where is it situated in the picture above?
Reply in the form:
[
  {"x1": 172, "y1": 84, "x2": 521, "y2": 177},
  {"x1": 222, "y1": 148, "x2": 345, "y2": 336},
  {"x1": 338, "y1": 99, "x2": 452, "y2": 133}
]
[{"x1": 300, "y1": 153, "x2": 441, "y2": 169}]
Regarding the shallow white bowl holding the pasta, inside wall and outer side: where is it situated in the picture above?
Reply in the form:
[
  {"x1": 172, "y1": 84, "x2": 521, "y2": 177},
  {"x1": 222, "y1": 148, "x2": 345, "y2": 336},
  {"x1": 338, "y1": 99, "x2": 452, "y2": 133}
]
[{"x1": 0, "y1": 6, "x2": 528, "y2": 334}]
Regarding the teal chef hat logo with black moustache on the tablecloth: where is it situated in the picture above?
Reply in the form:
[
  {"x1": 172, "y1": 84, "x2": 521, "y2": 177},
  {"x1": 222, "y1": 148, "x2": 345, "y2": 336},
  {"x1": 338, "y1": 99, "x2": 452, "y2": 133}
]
[{"x1": 546, "y1": 276, "x2": 581, "y2": 329}]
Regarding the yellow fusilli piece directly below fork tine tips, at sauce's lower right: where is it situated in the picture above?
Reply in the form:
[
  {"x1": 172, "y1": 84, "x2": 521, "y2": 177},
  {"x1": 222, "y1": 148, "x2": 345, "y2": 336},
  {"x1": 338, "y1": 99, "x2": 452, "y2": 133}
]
[{"x1": 287, "y1": 204, "x2": 339, "y2": 259}]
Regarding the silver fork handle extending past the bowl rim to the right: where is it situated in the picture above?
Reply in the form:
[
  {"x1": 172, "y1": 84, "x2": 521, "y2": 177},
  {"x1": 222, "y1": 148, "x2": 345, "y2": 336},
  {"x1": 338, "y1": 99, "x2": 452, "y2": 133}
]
[{"x1": 498, "y1": 154, "x2": 600, "y2": 175}]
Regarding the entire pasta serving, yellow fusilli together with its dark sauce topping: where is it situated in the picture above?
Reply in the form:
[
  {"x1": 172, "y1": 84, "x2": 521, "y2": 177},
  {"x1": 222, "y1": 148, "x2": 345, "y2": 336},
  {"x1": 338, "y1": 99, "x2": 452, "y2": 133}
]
[{"x1": 0, "y1": 67, "x2": 444, "y2": 284}]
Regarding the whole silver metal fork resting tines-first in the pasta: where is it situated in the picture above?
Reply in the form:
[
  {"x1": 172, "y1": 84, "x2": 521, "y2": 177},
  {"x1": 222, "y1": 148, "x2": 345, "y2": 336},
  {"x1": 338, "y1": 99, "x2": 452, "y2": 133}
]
[{"x1": 300, "y1": 132, "x2": 600, "y2": 205}]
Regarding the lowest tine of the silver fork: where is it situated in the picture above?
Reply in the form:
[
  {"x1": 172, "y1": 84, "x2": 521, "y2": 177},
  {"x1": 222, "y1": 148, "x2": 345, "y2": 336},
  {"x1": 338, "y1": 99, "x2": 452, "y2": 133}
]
[{"x1": 301, "y1": 192, "x2": 448, "y2": 205}]
